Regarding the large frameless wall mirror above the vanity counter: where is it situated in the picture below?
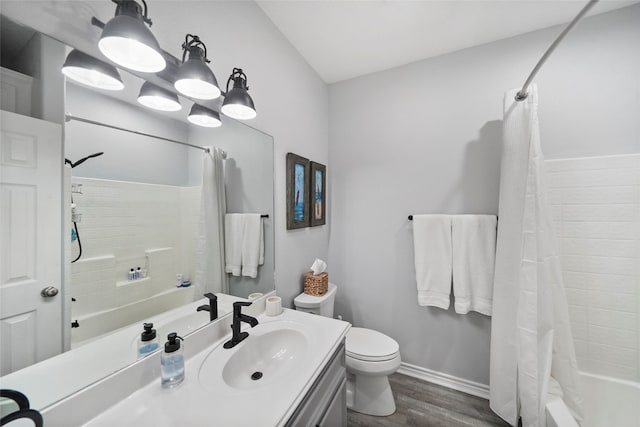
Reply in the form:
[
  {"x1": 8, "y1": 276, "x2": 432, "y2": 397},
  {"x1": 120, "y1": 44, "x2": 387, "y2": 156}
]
[{"x1": 0, "y1": 9, "x2": 275, "y2": 409}]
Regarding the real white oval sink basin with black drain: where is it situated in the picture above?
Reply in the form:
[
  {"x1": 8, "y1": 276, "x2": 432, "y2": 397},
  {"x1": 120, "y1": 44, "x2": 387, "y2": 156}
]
[{"x1": 199, "y1": 321, "x2": 310, "y2": 390}]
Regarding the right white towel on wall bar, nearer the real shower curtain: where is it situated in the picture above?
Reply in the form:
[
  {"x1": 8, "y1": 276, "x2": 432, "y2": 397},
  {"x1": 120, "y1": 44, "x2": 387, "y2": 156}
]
[{"x1": 451, "y1": 215, "x2": 498, "y2": 316}]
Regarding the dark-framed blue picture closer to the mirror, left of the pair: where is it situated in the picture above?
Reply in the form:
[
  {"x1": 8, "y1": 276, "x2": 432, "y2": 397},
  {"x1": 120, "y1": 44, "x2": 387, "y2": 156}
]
[{"x1": 287, "y1": 153, "x2": 310, "y2": 230}]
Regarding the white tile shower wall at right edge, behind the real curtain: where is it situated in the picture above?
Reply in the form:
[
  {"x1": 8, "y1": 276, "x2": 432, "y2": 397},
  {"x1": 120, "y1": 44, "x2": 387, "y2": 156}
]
[{"x1": 546, "y1": 154, "x2": 640, "y2": 381}]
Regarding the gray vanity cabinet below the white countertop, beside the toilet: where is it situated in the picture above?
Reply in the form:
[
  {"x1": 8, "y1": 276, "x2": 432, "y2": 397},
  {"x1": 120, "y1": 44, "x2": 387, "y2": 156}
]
[{"x1": 286, "y1": 341, "x2": 347, "y2": 427}]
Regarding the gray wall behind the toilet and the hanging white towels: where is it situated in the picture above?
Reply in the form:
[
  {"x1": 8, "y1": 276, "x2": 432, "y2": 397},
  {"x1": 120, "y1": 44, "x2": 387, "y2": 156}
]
[{"x1": 328, "y1": 5, "x2": 640, "y2": 384}]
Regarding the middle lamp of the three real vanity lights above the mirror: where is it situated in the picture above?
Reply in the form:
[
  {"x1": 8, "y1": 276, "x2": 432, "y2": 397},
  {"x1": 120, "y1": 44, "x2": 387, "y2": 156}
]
[{"x1": 174, "y1": 34, "x2": 220, "y2": 99}]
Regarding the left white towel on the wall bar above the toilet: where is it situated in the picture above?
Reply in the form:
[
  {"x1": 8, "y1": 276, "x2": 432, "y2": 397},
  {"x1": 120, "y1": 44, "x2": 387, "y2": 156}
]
[{"x1": 413, "y1": 215, "x2": 452, "y2": 310}]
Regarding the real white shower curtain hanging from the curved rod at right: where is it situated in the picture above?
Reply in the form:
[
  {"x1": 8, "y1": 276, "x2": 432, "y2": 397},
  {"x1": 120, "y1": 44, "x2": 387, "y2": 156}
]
[{"x1": 490, "y1": 85, "x2": 581, "y2": 427}]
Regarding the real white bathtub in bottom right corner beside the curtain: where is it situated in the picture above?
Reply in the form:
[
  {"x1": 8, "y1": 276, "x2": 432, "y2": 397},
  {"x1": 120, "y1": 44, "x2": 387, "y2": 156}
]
[{"x1": 546, "y1": 372, "x2": 640, "y2": 427}]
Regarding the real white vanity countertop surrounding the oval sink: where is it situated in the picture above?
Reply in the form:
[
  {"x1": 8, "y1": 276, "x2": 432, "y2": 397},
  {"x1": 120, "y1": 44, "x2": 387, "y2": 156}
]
[{"x1": 85, "y1": 309, "x2": 350, "y2": 427}]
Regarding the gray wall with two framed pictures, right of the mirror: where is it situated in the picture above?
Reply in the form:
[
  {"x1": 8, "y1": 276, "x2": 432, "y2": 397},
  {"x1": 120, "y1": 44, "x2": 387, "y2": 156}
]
[{"x1": 221, "y1": 2, "x2": 330, "y2": 307}]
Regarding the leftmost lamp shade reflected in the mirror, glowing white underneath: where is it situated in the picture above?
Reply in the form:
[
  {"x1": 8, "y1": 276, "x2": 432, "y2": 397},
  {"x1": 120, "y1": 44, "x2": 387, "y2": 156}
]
[{"x1": 62, "y1": 49, "x2": 124, "y2": 90}]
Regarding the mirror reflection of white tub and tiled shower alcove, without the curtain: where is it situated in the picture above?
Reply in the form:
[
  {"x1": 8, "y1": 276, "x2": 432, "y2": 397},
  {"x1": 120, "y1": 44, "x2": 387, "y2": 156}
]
[{"x1": 64, "y1": 78, "x2": 205, "y2": 348}]
